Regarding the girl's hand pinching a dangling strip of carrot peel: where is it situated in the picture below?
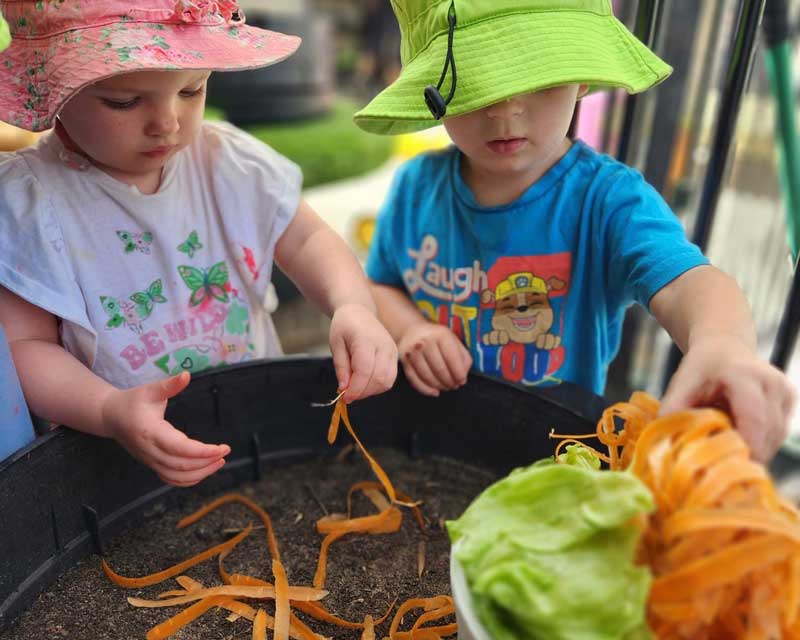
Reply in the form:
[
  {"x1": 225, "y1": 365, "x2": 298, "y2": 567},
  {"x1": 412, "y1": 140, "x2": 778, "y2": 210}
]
[{"x1": 330, "y1": 304, "x2": 397, "y2": 402}]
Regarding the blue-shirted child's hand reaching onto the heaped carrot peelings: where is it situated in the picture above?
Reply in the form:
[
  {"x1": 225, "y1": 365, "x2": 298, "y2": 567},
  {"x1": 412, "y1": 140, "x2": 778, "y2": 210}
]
[{"x1": 660, "y1": 337, "x2": 796, "y2": 463}]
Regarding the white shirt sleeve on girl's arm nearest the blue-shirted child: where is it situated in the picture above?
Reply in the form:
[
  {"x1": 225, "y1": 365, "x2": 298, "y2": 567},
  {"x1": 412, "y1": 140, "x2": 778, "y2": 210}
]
[{"x1": 202, "y1": 122, "x2": 303, "y2": 295}]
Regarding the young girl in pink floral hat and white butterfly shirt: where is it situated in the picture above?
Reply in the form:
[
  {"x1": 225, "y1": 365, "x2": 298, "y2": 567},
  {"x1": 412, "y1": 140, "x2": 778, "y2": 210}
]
[{"x1": 0, "y1": 0, "x2": 397, "y2": 486}]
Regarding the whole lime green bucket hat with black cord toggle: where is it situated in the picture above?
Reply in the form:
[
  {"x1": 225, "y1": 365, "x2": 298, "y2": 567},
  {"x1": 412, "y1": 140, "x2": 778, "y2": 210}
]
[{"x1": 355, "y1": 0, "x2": 672, "y2": 134}]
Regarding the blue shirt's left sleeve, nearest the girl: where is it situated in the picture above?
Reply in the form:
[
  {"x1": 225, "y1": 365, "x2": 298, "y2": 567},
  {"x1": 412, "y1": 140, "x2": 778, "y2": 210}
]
[{"x1": 365, "y1": 165, "x2": 409, "y2": 289}]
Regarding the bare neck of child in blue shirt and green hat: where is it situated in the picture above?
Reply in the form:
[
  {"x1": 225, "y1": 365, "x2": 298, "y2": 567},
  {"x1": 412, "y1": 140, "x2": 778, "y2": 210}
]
[{"x1": 461, "y1": 138, "x2": 572, "y2": 207}]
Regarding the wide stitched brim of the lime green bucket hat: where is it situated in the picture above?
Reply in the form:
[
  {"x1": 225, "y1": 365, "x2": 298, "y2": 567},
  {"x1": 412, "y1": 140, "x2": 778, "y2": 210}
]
[{"x1": 354, "y1": 11, "x2": 672, "y2": 134}]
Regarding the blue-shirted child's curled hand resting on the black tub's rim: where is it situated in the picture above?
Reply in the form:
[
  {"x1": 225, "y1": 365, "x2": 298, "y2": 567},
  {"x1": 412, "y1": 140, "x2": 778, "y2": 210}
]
[{"x1": 397, "y1": 322, "x2": 472, "y2": 397}]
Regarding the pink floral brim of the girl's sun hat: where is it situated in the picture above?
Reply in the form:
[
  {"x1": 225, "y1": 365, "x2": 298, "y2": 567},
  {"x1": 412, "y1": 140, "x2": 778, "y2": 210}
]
[{"x1": 0, "y1": 22, "x2": 301, "y2": 131}]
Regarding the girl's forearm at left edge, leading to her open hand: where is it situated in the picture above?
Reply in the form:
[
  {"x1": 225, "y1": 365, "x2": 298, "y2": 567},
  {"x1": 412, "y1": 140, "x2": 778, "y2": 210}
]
[{"x1": 10, "y1": 339, "x2": 116, "y2": 437}]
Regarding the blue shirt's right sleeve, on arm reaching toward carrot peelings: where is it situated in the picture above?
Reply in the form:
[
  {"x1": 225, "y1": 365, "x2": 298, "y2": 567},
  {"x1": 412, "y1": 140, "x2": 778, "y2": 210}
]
[{"x1": 600, "y1": 167, "x2": 709, "y2": 307}]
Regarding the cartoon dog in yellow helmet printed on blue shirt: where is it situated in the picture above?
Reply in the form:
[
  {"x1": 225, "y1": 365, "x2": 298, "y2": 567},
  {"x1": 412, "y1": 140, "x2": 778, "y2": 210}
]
[{"x1": 481, "y1": 271, "x2": 565, "y2": 351}]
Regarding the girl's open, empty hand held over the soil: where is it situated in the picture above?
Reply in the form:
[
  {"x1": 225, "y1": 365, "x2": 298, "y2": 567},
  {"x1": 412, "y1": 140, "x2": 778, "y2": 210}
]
[{"x1": 103, "y1": 372, "x2": 231, "y2": 487}]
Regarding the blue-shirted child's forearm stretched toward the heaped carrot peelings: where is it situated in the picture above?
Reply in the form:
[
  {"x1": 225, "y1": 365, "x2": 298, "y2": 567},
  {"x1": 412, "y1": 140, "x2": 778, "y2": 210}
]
[{"x1": 650, "y1": 266, "x2": 756, "y2": 353}]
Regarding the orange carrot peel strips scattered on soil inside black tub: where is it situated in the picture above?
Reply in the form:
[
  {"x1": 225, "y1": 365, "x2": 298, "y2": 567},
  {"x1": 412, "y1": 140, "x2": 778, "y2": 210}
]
[{"x1": 103, "y1": 398, "x2": 457, "y2": 640}]
